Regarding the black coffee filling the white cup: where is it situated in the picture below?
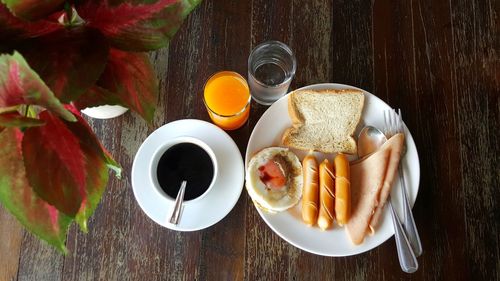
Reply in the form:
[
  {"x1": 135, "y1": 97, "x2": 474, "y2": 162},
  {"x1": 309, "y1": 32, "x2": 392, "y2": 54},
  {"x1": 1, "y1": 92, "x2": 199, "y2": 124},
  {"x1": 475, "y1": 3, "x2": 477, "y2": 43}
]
[{"x1": 156, "y1": 142, "x2": 214, "y2": 200}]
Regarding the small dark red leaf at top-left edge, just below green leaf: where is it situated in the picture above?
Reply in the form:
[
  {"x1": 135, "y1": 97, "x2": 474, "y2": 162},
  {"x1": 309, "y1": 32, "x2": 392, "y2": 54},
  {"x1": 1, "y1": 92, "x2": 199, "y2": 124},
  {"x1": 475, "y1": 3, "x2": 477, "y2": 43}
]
[{"x1": 0, "y1": 3, "x2": 63, "y2": 41}]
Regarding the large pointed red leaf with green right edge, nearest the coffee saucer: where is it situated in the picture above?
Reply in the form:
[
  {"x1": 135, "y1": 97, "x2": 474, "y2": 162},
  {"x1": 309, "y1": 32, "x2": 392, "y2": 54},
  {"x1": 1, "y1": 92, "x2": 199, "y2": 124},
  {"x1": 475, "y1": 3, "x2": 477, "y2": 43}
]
[{"x1": 23, "y1": 108, "x2": 121, "y2": 232}]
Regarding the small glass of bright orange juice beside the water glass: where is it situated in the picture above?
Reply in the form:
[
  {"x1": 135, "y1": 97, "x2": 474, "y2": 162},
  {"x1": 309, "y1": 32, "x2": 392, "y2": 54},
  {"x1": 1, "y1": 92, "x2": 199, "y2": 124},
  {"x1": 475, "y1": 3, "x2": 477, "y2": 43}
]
[{"x1": 203, "y1": 71, "x2": 251, "y2": 130}]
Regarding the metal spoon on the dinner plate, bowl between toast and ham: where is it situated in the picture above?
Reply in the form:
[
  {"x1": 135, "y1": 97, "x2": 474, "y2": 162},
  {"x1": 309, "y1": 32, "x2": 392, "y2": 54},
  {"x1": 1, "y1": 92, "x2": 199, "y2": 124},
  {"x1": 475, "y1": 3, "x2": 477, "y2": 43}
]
[{"x1": 358, "y1": 126, "x2": 418, "y2": 273}]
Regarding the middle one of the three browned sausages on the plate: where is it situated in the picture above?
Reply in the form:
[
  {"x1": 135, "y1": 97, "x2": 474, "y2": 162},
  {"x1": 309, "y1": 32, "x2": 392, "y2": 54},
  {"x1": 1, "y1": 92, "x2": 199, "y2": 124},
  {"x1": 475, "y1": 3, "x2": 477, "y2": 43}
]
[{"x1": 318, "y1": 159, "x2": 335, "y2": 230}]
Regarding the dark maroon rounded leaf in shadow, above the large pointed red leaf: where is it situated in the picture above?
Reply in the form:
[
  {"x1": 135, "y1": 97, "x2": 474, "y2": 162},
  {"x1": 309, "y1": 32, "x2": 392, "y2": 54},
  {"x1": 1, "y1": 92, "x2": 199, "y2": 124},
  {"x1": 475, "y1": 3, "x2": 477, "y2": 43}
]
[{"x1": 19, "y1": 28, "x2": 108, "y2": 103}]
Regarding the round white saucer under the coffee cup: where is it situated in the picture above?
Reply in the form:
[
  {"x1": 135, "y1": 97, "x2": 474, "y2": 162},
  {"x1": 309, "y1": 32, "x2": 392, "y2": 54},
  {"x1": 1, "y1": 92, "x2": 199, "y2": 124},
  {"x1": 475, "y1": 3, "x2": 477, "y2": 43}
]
[{"x1": 132, "y1": 119, "x2": 245, "y2": 231}]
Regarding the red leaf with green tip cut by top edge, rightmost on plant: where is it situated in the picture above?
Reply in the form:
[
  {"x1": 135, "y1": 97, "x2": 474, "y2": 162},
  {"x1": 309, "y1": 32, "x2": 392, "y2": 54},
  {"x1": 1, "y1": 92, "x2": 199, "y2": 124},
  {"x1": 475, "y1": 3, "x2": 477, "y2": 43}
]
[{"x1": 77, "y1": 0, "x2": 201, "y2": 52}]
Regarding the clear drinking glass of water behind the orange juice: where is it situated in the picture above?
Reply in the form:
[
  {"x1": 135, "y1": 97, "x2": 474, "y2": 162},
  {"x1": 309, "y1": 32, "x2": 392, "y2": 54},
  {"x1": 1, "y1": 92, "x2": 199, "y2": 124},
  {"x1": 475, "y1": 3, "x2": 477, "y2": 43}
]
[{"x1": 248, "y1": 41, "x2": 297, "y2": 105}]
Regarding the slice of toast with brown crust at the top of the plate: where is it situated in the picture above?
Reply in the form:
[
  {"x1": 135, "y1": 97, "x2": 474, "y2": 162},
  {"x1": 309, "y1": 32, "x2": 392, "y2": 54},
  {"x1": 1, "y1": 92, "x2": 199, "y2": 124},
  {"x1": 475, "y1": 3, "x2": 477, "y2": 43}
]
[{"x1": 282, "y1": 89, "x2": 365, "y2": 154}]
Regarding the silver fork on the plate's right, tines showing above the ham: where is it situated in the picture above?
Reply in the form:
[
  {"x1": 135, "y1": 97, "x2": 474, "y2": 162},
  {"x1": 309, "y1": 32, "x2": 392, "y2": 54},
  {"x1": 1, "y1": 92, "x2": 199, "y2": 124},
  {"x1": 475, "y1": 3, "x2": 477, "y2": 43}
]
[{"x1": 384, "y1": 109, "x2": 422, "y2": 257}]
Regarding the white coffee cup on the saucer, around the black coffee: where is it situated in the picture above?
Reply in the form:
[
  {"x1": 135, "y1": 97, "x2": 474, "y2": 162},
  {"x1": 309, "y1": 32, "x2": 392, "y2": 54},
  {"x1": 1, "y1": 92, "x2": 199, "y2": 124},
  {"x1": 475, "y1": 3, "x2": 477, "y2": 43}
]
[{"x1": 149, "y1": 136, "x2": 219, "y2": 205}]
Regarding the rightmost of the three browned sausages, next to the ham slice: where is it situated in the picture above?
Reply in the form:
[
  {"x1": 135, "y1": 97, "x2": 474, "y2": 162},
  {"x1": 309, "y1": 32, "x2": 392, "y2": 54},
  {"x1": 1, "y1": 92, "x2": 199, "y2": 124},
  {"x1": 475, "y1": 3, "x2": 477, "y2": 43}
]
[{"x1": 334, "y1": 153, "x2": 351, "y2": 225}]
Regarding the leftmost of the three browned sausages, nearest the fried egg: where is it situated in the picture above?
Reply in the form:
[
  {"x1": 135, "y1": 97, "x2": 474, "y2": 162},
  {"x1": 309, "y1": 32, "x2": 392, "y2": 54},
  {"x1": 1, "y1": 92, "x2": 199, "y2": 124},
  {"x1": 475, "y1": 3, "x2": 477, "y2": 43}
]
[{"x1": 302, "y1": 153, "x2": 319, "y2": 226}]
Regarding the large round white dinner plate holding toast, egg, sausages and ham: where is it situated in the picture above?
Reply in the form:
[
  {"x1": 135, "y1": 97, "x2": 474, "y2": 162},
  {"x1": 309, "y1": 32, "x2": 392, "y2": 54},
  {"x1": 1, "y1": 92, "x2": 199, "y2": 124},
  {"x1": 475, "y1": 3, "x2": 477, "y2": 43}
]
[{"x1": 245, "y1": 83, "x2": 420, "y2": 257}]
